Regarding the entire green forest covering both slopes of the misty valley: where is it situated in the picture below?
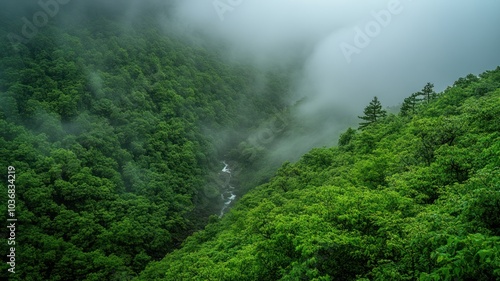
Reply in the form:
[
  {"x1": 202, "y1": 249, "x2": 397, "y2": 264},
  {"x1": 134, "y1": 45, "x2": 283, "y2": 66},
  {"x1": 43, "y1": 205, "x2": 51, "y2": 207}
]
[{"x1": 0, "y1": 1, "x2": 500, "y2": 281}]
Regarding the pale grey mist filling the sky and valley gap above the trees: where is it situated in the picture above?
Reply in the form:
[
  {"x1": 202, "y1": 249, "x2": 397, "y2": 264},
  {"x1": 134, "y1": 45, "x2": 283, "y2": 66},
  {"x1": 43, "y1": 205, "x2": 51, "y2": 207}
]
[{"x1": 3, "y1": 0, "x2": 500, "y2": 161}]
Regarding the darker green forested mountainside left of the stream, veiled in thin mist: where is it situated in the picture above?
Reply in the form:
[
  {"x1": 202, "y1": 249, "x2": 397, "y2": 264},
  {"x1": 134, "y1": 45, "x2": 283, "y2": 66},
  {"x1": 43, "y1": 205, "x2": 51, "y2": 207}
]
[{"x1": 0, "y1": 11, "x2": 290, "y2": 280}]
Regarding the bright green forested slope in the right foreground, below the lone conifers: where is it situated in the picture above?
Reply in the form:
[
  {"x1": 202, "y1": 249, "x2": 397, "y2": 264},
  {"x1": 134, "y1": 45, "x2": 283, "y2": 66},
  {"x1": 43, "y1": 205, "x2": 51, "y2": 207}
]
[{"x1": 138, "y1": 67, "x2": 500, "y2": 280}]
